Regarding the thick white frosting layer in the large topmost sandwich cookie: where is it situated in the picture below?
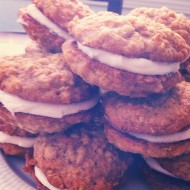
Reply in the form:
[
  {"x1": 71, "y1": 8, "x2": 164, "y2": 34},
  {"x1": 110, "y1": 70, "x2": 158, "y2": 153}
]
[{"x1": 77, "y1": 42, "x2": 180, "y2": 75}]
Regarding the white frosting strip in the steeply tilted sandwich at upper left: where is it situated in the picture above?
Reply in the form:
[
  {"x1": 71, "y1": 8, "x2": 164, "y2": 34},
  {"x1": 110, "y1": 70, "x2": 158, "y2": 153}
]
[{"x1": 21, "y1": 4, "x2": 73, "y2": 40}]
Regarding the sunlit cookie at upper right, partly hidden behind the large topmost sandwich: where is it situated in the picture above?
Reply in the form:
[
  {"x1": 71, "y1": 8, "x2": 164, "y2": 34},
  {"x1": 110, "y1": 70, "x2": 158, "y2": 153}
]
[{"x1": 129, "y1": 7, "x2": 190, "y2": 45}]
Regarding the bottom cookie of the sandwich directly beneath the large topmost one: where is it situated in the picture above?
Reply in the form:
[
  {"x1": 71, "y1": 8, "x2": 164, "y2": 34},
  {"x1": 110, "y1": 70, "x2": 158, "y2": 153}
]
[{"x1": 104, "y1": 125, "x2": 190, "y2": 158}]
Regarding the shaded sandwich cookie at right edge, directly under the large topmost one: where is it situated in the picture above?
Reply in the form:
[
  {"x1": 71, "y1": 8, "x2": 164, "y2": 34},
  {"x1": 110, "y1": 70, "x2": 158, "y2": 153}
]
[{"x1": 102, "y1": 81, "x2": 190, "y2": 158}]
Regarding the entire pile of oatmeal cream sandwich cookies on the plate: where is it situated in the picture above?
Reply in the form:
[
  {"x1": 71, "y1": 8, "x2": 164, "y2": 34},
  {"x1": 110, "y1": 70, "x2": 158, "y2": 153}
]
[{"x1": 0, "y1": 0, "x2": 190, "y2": 190}]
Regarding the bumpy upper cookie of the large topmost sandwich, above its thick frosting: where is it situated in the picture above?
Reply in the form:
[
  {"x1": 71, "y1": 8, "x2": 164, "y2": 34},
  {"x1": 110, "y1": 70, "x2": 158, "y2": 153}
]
[{"x1": 68, "y1": 12, "x2": 189, "y2": 63}]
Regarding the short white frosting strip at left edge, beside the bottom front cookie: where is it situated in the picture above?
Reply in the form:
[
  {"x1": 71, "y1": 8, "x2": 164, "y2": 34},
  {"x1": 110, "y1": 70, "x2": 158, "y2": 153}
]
[{"x1": 0, "y1": 131, "x2": 35, "y2": 148}]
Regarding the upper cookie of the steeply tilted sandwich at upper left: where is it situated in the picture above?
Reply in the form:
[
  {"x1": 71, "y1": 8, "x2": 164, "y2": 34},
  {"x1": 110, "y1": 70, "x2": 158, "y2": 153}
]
[{"x1": 32, "y1": 0, "x2": 93, "y2": 31}]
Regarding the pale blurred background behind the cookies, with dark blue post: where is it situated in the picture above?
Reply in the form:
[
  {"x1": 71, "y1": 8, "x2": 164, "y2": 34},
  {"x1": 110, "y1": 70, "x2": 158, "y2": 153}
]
[{"x1": 0, "y1": 0, "x2": 190, "y2": 32}]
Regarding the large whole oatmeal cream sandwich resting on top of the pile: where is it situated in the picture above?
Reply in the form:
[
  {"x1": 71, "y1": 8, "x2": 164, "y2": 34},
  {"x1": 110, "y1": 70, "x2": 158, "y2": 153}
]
[{"x1": 63, "y1": 12, "x2": 189, "y2": 97}]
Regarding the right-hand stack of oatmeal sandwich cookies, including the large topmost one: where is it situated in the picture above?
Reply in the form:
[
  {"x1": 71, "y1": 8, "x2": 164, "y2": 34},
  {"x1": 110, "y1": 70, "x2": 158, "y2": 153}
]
[{"x1": 62, "y1": 5, "x2": 190, "y2": 189}]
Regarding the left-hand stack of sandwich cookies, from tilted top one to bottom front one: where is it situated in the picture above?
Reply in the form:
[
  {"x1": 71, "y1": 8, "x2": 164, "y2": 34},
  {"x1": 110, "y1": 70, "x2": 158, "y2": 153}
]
[{"x1": 0, "y1": 0, "x2": 132, "y2": 190}]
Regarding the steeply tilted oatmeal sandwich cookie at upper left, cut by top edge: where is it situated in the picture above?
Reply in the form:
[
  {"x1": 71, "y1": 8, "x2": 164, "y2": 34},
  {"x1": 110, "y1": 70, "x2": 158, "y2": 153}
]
[{"x1": 18, "y1": 0, "x2": 93, "y2": 52}]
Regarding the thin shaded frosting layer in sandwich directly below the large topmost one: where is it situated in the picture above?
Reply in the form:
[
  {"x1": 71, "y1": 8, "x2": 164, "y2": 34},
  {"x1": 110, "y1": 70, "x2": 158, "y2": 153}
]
[{"x1": 129, "y1": 129, "x2": 190, "y2": 143}]
